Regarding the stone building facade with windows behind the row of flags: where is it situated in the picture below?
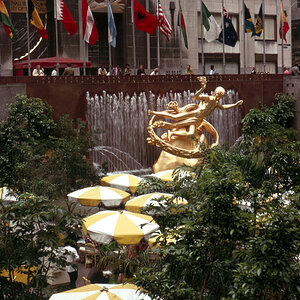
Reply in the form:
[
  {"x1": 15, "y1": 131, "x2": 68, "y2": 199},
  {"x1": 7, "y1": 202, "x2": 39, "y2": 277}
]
[{"x1": 0, "y1": 0, "x2": 292, "y2": 75}]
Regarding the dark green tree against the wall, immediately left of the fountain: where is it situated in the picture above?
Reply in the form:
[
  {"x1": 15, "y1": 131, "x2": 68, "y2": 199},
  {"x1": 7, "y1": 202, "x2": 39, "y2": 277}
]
[{"x1": 35, "y1": 116, "x2": 99, "y2": 198}]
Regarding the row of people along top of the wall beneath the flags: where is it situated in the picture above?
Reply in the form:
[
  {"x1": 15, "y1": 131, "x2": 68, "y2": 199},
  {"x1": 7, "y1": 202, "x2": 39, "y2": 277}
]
[{"x1": 32, "y1": 63, "x2": 300, "y2": 76}]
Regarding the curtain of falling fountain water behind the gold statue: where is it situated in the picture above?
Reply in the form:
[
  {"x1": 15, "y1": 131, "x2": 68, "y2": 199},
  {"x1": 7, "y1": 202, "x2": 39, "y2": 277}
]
[{"x1": 86, "y1": 77, "x2": 241, "y2": 174}]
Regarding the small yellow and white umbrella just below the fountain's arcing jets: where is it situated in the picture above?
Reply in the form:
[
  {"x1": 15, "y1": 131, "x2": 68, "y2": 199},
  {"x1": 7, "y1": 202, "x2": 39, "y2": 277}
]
[{"x1": 101, "y1": 174, "x2": 142, "y2": 193}]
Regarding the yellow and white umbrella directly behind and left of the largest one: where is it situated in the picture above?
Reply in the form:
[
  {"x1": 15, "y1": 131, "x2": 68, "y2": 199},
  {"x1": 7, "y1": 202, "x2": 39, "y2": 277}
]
[{"x1": 68, "y1": 186, "x2": 130, "y2": 207}]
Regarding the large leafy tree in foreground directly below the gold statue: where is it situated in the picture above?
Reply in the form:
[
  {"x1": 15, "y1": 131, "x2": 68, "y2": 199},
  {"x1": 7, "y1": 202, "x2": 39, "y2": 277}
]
[{"x1": 135, "y1": 149, "x2": 250, "y2": 299}]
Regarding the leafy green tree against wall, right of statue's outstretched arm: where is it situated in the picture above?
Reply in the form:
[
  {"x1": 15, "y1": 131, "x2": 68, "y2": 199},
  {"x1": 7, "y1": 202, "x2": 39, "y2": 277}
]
[{"x1": 236, "y1": 94, "x2": 300, "y2": 189}]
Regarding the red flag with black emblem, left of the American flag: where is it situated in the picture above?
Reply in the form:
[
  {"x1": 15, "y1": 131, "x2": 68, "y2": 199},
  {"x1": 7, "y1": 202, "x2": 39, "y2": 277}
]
[{"x1": 134, "y1": 0, "x2": 158, "y2": 35}]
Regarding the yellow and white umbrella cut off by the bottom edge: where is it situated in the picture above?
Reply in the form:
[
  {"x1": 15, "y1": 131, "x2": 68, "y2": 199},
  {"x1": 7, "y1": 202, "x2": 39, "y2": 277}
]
[{"x1": 49, "y1": 283, "x2": 151, "y2": 300}]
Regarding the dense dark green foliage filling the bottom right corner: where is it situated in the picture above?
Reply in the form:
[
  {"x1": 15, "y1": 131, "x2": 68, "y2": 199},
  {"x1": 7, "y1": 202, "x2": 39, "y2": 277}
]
[{"x1": 231, "y1": 195, "x2": 300, "y2": 300}]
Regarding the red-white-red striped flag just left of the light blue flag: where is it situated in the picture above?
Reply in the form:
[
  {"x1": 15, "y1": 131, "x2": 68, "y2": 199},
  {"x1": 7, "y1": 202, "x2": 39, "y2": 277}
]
[{"x1": 82, "y1": 0, "x2": 99, "y2": 46}]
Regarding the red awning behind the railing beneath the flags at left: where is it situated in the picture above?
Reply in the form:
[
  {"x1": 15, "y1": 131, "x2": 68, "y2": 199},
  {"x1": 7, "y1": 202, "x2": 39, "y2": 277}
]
[{"x1": 14, "y1": 57, "x2": 91, "y2": 70}]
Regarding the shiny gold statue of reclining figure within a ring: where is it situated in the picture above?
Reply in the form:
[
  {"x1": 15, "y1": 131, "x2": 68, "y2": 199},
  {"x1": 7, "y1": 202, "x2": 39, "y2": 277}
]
[{"x1": 147, "y1": 77, "x2": 243, "y2": 173}]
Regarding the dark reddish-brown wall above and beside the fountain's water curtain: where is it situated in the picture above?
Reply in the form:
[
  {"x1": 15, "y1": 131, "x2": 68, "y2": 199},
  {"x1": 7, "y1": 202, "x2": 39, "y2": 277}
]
[{"x1": 0, "y1": 74, "x2": 283, "y2": 119}]
